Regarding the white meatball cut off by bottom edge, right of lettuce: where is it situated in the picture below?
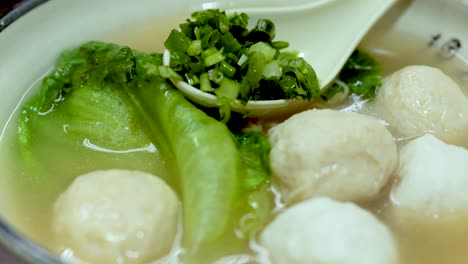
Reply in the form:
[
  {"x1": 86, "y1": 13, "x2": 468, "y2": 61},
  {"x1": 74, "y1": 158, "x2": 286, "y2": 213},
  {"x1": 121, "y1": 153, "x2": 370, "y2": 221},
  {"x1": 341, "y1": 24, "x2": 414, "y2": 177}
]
[{"x1": 260, "y1": 198, "x2": 399, "y2": 264}]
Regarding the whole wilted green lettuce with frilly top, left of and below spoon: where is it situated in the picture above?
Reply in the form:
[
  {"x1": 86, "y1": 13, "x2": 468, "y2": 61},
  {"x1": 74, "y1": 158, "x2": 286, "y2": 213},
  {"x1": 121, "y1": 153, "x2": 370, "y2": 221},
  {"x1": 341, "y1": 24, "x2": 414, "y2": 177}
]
[{"x1": 18, "y1": 40, "x2": 271, "y2": 263}]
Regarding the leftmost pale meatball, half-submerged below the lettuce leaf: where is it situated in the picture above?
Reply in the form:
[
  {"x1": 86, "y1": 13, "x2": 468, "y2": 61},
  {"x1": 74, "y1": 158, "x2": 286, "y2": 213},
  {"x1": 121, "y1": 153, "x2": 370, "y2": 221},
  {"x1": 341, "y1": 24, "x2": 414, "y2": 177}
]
[{"x1": 53, "y1": 170, "x2": 179, "y2": 263}]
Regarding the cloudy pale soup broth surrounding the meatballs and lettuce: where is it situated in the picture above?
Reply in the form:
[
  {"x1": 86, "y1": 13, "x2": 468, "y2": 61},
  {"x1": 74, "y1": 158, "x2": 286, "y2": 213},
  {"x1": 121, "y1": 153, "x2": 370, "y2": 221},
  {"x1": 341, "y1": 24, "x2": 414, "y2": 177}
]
[{"x1": 0, "y1": 21, "x2": 468, "y2": 264}]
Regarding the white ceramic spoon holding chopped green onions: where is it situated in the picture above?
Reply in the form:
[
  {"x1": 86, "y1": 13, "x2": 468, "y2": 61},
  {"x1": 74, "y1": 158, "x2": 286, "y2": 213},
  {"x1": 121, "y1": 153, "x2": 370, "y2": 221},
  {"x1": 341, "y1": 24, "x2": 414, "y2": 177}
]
[{"x1": 164, "y1": 0, "x2": 396, "y2": 117}]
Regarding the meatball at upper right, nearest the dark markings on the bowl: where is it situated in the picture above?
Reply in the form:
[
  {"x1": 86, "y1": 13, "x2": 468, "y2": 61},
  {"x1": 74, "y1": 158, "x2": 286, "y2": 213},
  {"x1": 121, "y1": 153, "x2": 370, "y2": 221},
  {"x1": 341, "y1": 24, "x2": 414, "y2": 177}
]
[{"x1": 370, "y1": 66, "x2": 468, "y2": 146}]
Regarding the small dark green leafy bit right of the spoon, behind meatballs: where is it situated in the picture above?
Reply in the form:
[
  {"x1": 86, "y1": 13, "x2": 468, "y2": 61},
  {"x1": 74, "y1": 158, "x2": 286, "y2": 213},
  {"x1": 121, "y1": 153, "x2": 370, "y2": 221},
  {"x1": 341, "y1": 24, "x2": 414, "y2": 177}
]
[{"x1": 323, "y1": 50, "x2": 382, "y2": 100}]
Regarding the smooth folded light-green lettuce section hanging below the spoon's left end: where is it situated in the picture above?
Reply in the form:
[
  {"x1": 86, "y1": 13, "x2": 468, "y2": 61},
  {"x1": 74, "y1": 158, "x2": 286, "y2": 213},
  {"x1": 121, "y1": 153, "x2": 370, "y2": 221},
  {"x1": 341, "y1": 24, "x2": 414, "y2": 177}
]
[{"x1": 128, "y1": 76, "x2": 243, "y2": 258}]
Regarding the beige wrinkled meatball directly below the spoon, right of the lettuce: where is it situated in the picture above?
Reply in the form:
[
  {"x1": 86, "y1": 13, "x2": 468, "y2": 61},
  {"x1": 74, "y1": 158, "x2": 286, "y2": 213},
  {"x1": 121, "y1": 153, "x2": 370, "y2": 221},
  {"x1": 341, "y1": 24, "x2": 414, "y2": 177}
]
[{"x1": 269, "y1": 110, "x2": 397, "y2": 203}]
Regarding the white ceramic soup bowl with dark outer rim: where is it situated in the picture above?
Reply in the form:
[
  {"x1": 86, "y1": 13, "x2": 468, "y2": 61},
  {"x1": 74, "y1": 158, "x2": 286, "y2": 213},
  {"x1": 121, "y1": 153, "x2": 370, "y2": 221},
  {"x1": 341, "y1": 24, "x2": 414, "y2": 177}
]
[{"x1": 0, "y1": 0, "x2": 468, "y2": 263}]
